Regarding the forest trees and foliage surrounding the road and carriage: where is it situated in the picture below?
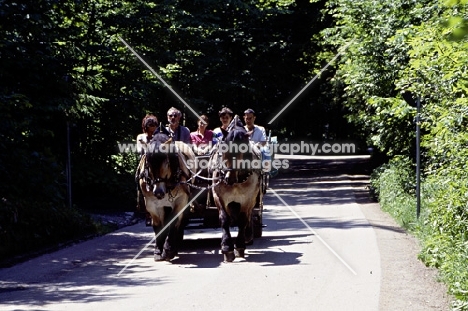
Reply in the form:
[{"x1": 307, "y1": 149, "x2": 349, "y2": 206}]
[{"x1": 0, "y1": 0, "x2": 468, "y2": 310}]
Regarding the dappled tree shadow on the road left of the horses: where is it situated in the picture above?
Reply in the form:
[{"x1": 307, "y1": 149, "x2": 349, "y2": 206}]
[{"x1": 0, "y1": 227, "x2": 171, "y2": 309}]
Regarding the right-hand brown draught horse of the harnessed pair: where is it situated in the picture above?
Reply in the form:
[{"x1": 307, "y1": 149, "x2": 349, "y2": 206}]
[{"x1": 209, "y1": 116, "x2": 262, "y2": 262}]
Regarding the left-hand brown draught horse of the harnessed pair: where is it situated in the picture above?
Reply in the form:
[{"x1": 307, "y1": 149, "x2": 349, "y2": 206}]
[{"x1": 138, "y1": 126, "x2": 196, "y2": 261}]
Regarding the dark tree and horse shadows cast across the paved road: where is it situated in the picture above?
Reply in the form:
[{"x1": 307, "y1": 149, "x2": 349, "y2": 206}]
[{"x1": 0, "y1": 159, "x2": 398, "y2": 309}]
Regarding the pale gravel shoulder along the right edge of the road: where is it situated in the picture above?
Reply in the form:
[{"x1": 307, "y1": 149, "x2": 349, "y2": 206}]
[{"x1": 357, "y1": 190, "x2": 451, "y2": 311}]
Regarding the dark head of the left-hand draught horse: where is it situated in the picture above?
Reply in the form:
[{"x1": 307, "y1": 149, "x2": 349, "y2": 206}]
[{"x1": 146, "y1": 126, "x2": 178, "y2": 199}]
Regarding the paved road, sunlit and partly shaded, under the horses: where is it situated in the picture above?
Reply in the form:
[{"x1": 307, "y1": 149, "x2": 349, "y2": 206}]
[{"x1": 0, "y1": 158, "x2": 448, "y2": 310}]
